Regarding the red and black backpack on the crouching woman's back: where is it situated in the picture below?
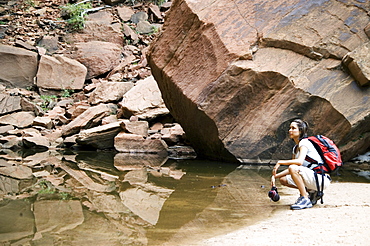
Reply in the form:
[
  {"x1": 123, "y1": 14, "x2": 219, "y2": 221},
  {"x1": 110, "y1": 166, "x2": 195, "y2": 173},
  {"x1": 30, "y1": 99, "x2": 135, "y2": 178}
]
[{"x1": 307, "y1": 135, "x2": 343, "y2": 173}]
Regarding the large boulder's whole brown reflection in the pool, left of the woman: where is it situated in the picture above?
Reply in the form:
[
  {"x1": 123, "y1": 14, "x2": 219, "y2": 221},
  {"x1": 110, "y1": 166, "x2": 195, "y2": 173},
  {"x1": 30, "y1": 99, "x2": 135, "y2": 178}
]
[{"x1": 147, "y1": 163, "x2": 274, "y2": 245}]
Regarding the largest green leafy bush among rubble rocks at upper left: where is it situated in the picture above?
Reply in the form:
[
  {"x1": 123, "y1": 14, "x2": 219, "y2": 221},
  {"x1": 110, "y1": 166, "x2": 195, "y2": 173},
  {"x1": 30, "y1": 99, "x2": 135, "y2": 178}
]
[{"x1": 61, "y1": 2, "x2": 92, "y2": 31}]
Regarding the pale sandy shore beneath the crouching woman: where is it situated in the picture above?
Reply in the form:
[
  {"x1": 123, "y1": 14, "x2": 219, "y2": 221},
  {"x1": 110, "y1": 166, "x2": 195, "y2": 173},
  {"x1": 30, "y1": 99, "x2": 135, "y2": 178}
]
[{"x1": 196, "y1": 183, "x2": 370, "y2": 246}]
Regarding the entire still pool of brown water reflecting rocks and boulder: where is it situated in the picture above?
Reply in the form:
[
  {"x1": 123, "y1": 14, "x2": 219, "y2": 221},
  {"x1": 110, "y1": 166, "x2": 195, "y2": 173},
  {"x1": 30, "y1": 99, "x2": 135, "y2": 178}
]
[{"x1": 0, "y1": 150, "x2": 276, "y2": 245}]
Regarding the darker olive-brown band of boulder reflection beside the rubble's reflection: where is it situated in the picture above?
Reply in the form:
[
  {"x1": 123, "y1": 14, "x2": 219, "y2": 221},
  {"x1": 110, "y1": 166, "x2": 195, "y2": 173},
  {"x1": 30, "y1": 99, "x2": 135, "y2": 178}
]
[{"x1": 147, "y1": 161, "x2": 235, "y2": 245}]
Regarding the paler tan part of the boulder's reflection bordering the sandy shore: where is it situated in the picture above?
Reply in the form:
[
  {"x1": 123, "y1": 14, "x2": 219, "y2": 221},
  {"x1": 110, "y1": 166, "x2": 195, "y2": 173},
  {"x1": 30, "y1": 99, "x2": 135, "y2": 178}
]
[{"x1": 148, "y1": 166, "x2": 273, "y2": 245}]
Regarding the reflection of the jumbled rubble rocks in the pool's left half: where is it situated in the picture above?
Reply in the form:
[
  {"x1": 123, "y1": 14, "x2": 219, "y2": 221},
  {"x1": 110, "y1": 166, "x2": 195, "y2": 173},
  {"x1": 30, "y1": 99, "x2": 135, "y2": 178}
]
[{"x1": 0, "y1": 152, "x2": 184, "y2": 245}]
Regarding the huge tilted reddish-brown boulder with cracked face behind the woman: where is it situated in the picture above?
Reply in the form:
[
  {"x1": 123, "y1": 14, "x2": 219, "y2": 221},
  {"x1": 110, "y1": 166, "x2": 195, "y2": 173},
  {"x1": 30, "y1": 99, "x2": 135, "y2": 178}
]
[{"x1": 148, "y1": 0, "x2": 370, "y2": 162}]
